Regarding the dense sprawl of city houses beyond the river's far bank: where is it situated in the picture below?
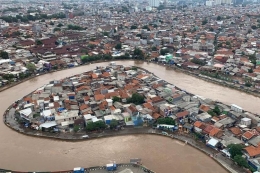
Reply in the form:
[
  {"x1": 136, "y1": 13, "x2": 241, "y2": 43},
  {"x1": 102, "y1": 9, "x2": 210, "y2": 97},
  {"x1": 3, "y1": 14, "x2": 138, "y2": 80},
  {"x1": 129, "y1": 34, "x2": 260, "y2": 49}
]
[{"x1": 0, "y1": 1, "x2": 260, "y2": 90}]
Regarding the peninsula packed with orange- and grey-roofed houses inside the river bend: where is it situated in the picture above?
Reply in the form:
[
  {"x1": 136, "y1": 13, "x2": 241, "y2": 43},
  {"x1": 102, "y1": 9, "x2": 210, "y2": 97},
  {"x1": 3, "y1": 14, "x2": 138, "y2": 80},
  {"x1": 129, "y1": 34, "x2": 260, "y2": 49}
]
[{"x1": 4, "y1": 62, "x2": 260, "y2": 172}]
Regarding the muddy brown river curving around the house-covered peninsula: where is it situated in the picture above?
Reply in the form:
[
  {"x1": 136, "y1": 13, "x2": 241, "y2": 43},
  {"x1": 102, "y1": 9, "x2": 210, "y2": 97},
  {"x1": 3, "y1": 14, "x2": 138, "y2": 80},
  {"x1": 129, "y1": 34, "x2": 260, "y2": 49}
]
[{"x1": 0, "y1": 61, "x2": 260, "y2": 173}]
